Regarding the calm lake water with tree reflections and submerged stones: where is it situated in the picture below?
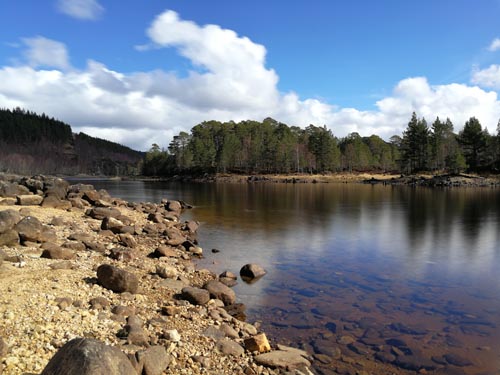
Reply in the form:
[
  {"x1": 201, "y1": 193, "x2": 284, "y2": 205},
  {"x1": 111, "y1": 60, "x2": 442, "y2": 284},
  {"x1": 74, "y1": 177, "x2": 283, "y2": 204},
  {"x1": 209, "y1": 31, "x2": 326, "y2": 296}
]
[{"x1": 69, "y1": 181, "x2": 500, "y2": 374}]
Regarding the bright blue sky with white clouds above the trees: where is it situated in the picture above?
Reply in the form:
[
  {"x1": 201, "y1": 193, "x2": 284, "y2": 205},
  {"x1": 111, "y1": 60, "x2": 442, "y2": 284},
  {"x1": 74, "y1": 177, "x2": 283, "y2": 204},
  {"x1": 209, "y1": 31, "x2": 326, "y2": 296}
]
[{"x1": 0, "y1": 0, "x2": 500, "y2": 151}]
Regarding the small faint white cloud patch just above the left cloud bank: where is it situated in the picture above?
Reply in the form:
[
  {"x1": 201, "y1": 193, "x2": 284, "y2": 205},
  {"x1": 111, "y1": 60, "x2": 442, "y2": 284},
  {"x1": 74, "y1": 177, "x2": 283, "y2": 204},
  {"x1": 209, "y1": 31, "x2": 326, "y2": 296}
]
[{"x1": 22, "y1": 36, "x2": 70, "y2": 69}]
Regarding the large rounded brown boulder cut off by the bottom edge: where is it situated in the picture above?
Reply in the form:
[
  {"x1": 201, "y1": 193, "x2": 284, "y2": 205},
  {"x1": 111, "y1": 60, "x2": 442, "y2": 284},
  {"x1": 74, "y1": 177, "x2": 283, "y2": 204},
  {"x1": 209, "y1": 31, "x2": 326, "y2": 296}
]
[{"x1": 41, "y1": 338, "x2": 137, "y2": 375}]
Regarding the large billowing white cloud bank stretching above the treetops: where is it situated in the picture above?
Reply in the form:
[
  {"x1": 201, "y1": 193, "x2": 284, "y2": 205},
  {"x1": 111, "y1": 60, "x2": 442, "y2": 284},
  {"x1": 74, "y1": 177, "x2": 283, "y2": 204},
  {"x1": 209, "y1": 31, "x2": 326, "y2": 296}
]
[{"x1": 0, "y1": 11, "x2": 500, "y2": 150}]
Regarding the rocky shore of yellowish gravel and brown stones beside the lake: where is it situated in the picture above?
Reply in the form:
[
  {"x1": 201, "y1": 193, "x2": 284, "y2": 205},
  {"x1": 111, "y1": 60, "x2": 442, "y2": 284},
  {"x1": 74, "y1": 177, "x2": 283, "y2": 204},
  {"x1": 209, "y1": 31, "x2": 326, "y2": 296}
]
[{"x1": 0, "y1": 176, "x2": 312, "y2": 375}]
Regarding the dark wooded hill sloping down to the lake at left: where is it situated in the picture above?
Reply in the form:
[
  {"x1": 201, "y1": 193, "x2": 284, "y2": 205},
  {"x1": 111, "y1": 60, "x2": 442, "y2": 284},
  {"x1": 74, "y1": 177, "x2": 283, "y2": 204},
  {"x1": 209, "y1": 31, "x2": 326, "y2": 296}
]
[{"x1": 0, "y1": 108, "x2": 144, "y2": 176}]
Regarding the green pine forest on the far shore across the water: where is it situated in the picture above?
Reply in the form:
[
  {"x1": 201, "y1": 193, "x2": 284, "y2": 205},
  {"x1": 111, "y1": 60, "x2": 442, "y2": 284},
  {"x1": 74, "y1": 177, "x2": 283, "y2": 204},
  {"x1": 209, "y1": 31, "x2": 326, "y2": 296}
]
[{"x1": 143, "y1": 113, "x2": 500, "y2": 176}]
